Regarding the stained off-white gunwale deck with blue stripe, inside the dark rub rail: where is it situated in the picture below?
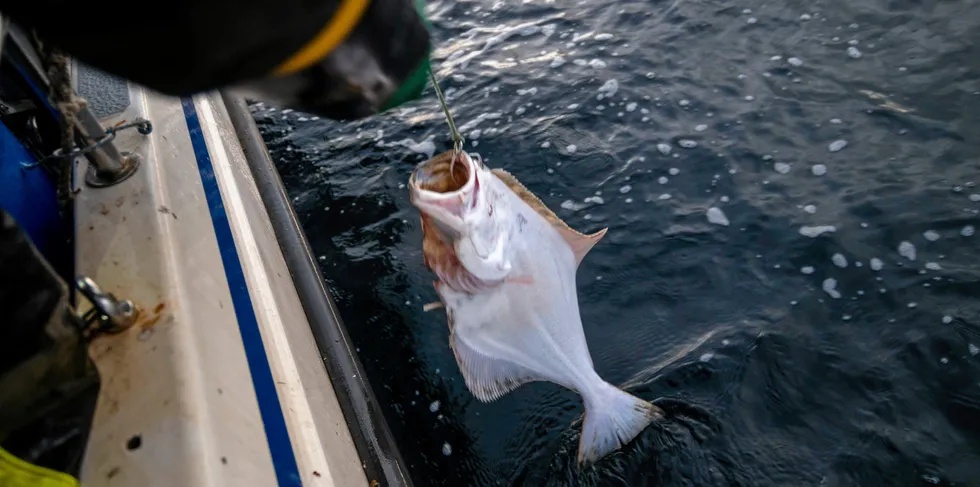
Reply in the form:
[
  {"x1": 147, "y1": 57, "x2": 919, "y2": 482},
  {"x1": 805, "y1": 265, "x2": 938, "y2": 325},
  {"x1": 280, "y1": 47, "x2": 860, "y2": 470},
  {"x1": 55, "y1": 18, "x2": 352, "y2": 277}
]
[{"x1": 73, "y1": 64, "x2": 374, "y2": 487}]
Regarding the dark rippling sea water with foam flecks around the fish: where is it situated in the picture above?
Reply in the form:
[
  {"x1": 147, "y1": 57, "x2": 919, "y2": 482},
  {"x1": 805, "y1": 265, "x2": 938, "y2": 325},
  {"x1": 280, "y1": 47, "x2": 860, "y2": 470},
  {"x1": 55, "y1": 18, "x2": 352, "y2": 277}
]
[{"x1": 253, "y1": 0, "x2": 980, "y2": 487}]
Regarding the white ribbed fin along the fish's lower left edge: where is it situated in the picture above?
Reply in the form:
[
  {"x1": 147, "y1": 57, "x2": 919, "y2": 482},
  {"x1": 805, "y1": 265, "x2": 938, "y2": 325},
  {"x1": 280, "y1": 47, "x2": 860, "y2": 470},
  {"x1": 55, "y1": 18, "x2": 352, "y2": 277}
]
[{"x1": 450, "y1": 327, "x2": 541, "y2": 402}]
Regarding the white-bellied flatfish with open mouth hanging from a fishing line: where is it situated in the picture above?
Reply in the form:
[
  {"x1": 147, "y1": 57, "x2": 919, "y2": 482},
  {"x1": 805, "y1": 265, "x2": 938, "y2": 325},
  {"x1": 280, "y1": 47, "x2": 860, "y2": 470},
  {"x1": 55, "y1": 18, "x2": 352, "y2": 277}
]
[{"x1": 408, "y1": 150, "x2": 664, "y2": 465}]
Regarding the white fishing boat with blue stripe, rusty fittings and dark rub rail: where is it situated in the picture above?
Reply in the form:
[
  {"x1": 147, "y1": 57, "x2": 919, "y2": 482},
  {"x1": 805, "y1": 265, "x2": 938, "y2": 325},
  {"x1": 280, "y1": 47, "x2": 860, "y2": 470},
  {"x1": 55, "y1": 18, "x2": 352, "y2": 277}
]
[{"x1": 0, "y1": 16, "x2": 411, "y2": 487}]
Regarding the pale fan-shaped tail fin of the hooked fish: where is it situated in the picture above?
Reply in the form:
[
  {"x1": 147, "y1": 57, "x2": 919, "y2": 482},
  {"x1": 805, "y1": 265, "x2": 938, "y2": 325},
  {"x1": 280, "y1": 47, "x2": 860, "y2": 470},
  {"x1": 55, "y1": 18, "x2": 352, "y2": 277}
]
[{"x1": 578, "y1": 382, "x2": 664, "y2": 464}]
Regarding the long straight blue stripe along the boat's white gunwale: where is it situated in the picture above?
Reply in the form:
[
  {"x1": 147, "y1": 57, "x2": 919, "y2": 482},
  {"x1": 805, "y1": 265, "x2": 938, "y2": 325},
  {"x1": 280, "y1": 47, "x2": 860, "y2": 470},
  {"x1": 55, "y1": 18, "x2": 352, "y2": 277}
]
[{"x1": 181, "y1": 98, "x2": 302, "y2": 486}]
